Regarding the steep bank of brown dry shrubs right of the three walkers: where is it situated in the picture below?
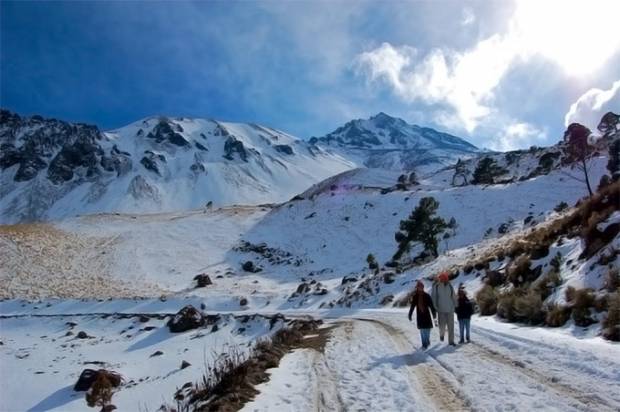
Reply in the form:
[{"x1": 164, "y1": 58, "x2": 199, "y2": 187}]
[{"x1": 472, "y1": 181, "x2": 620, "y2": 339}]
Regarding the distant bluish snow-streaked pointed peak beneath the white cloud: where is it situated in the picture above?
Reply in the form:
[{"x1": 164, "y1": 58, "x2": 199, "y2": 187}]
[{"x1": 310, "y1": 113, "x2": 480, "y2": 170}]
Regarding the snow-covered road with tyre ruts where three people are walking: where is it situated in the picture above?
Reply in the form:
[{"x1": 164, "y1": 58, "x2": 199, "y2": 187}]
[{"x1": 244, "y1": 311, "x2": 620, "y2": 412}]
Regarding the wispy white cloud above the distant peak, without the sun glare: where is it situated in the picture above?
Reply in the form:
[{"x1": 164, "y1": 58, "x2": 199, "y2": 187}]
[{"x1": 357, "y1": 35, "x2": 515, "y2": 133}]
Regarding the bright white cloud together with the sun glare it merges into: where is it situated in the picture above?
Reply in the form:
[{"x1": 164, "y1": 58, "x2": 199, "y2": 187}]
[{"x1": 356, "y1": 0, "x2": 620, "y2": 137}]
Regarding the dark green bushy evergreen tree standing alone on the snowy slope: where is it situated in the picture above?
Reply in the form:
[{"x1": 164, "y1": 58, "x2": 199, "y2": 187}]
[{"x1": 394, "y1": 197, "x2": 448, "y2": 260}]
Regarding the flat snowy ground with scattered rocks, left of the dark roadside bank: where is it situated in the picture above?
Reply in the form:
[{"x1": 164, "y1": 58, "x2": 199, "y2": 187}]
[{"x1": 0, "y1": 305, "x2": 294, "y2": 412}]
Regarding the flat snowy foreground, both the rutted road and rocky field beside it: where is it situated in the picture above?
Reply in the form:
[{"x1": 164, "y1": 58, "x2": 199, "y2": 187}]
[{"x1": 0, "y1": 302, "x2": 620, "y2": 411}]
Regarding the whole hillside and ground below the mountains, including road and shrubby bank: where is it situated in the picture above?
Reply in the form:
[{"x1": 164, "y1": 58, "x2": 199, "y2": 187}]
[{"x1": 0, "y1": 112, "x2": 620, "y2": 411}]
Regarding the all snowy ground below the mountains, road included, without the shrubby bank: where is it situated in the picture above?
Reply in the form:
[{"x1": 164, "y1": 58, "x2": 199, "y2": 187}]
[{"x1": 0, "y1": 158, "x2": 620, "y2": 412}]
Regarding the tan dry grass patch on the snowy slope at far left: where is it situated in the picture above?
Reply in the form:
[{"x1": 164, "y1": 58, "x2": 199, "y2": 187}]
[{"x1": 0, "y1": 223, "x2": 161, "y2": 299}]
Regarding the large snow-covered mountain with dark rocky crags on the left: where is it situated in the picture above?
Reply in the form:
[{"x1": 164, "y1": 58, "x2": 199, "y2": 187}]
[{"x1": 0, "y1": 110, "x2": 355, "y2": 223}]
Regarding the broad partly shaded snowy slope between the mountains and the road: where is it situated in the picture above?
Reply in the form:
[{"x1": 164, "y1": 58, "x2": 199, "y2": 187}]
[{"x1": 0, "y1": 157, "x2": 606, "y2": 310}]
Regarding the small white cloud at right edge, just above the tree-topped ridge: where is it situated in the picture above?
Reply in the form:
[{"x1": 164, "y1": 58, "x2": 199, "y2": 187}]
[{"x1": 564, "y1": 80, "x2": 620, "y2": 131}]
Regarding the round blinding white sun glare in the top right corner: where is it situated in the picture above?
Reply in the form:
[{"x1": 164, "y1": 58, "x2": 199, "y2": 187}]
[{"x1": 513, "y1": 0, "x2": 620, "y2": 76}]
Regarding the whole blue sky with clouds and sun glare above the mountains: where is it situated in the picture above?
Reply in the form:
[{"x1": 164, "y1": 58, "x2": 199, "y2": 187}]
[{"x1": 0, "y1": 0, "x2": 620, "y2": 149}]
